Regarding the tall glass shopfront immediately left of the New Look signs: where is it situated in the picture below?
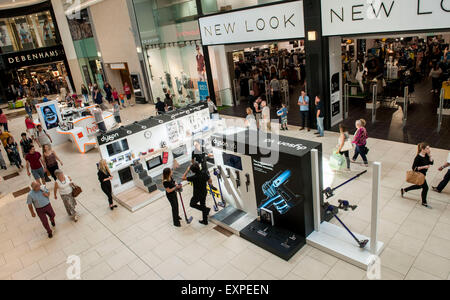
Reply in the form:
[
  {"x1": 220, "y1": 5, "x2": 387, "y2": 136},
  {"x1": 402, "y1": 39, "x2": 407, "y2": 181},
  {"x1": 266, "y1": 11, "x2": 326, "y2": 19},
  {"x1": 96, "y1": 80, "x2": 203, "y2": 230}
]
[{"x1": 130, "y1": 0, "x2": 207, "y2": 107}]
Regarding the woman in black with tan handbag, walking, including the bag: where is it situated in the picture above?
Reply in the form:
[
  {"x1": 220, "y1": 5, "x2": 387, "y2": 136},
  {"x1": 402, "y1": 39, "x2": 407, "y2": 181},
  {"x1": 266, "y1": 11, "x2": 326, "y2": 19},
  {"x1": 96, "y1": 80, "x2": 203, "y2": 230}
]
[{"x1": 400, "y1": 143, "x2": 434, "y2": 208}]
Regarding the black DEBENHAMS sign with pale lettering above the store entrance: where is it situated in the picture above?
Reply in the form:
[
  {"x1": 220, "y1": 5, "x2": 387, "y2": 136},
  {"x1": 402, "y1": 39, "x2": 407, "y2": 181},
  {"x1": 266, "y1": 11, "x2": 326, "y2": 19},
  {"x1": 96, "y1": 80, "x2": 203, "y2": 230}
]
[{"x1": 2, "y1": 46, "x2": 65, "y2": 69}]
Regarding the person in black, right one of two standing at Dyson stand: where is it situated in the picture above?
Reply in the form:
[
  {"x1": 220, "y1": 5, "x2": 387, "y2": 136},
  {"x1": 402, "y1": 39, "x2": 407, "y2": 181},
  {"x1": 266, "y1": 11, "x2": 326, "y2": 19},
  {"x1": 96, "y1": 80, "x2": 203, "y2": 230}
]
[{"x1": 183, "y1": 163, "x2": 212, "y2": 225}]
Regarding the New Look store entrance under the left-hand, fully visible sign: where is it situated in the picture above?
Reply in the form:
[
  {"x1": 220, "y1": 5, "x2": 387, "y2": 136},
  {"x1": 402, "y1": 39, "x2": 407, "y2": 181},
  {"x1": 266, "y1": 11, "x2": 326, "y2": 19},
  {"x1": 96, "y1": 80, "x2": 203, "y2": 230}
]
[{"x1": 209, "y1": 40, "x2": 306, "y2": 124}]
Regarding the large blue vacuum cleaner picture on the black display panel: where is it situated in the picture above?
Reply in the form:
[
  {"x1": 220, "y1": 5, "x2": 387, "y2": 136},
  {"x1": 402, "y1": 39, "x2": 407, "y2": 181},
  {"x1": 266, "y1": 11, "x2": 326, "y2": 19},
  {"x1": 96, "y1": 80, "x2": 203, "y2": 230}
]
[{"x1": 259, "y1": 170, "x2": 299, "y2": 215}]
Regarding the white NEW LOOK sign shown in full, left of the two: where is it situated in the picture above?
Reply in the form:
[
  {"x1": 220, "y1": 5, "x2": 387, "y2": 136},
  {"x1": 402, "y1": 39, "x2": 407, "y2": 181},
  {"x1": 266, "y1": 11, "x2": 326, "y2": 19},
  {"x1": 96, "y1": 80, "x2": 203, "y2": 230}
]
[{"x1": 199, "y1": 1, "x2": 305, "y2": 45}]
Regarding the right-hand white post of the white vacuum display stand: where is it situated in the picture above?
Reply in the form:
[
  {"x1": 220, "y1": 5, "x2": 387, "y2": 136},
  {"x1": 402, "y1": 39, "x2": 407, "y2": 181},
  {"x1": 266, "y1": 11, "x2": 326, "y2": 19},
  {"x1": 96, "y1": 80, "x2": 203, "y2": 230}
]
[{"x1": 370, "y1": 162, "x2": 381, "y2": 255}]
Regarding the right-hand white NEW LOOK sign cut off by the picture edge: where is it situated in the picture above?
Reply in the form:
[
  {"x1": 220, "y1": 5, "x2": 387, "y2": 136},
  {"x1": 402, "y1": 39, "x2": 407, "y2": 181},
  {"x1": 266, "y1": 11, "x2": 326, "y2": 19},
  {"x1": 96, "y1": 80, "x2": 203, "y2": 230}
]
[{"x1": 321, "y1": 0, "x2": 450, "y2": 36}]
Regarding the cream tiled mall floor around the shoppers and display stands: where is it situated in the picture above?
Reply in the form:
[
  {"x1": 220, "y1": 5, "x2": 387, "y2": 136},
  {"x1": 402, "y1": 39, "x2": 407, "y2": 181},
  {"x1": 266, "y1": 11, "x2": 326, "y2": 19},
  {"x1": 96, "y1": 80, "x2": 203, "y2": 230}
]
[{"x1": 0, "y1": 105, "x2": 450, "y2": 279}]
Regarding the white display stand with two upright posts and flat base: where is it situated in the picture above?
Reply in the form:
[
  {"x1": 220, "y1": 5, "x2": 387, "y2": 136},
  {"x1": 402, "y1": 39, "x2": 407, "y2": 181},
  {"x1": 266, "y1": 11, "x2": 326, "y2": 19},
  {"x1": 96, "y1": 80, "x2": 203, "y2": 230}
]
[{"x1": 306, "y1": 150, "x2": 384, "y2": 270}]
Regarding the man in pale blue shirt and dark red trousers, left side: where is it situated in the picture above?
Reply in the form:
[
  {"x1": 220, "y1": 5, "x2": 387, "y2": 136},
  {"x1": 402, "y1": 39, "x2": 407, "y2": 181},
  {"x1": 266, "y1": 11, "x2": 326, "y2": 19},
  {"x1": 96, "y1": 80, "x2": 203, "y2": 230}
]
[{"x1": 27, "y1": 181, "x2": 56, "y2": 239}]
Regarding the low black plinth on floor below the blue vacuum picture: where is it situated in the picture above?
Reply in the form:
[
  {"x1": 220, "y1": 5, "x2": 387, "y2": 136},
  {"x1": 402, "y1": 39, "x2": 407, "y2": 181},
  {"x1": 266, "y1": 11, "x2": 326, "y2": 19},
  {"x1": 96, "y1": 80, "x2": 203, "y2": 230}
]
[{"x1": 239, "y1": 220, "x2": 306, "y2": 261}]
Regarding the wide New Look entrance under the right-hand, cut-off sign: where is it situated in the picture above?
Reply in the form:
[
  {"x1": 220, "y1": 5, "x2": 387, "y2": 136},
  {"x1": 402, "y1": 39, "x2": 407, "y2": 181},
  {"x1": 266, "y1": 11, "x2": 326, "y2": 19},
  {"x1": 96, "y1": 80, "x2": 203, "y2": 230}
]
[{"x1": 332, "y1": 33, "x2": 450, "y2": 149}]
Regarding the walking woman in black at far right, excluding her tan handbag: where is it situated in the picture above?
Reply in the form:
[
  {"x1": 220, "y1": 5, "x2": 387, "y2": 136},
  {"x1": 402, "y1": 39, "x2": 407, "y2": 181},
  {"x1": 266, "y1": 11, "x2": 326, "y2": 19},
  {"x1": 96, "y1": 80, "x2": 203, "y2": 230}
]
[{"x1": 400, "y1": 143, "x2": 434, "y2": 208}]
